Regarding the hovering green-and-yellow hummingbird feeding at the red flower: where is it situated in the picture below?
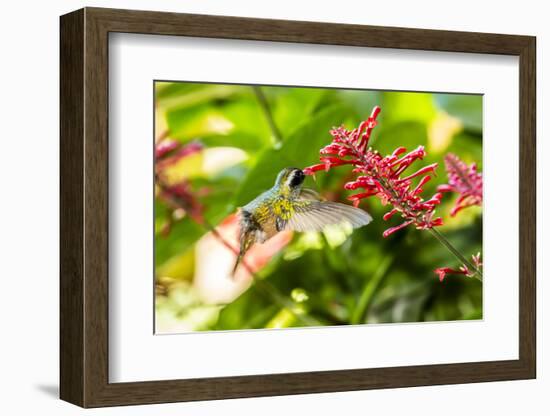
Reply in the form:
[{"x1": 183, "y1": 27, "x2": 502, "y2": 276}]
[{"x1": 233, "y1": 168, "x2": 372, "y2": 274}]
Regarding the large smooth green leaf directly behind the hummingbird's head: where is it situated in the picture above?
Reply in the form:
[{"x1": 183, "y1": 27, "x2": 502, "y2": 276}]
[{"x1": 235, "y1": 105, "x2": 349, "y2": 206}]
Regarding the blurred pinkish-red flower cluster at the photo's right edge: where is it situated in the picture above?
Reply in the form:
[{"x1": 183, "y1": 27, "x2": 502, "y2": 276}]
[{"x1": 437, "y1": 153, "x2": 483, "y2": 217}]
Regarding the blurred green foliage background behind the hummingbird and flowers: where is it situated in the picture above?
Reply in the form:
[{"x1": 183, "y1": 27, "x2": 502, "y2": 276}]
[{"x1": 155, "y1": 83, "x2": 482, "y2": 331}]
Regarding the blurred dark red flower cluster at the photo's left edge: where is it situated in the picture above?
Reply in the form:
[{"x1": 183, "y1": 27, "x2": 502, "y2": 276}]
[{"x1": 155, "y1": 139, "x2": 204, "y2": 223}]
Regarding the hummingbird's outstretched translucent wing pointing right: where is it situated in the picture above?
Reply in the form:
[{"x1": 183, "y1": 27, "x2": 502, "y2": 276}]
[{"x1": 284, "y1": 198, "x2": 372, "y2": 232}]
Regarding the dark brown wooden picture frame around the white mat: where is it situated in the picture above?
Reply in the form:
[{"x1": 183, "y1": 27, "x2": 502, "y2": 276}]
[{"x1": 60, "y1": 8, "x2": 536, "y2": 407}]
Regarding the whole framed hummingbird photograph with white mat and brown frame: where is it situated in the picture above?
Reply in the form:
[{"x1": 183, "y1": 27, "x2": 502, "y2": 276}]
[{"x1": 60, "y1": 8, "x2": 536, "y2": 407}]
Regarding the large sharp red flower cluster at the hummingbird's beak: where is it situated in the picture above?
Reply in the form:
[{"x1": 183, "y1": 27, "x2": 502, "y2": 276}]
[{"x1": 304, "y1": 107, "x2": 443, "y2": 237}]
